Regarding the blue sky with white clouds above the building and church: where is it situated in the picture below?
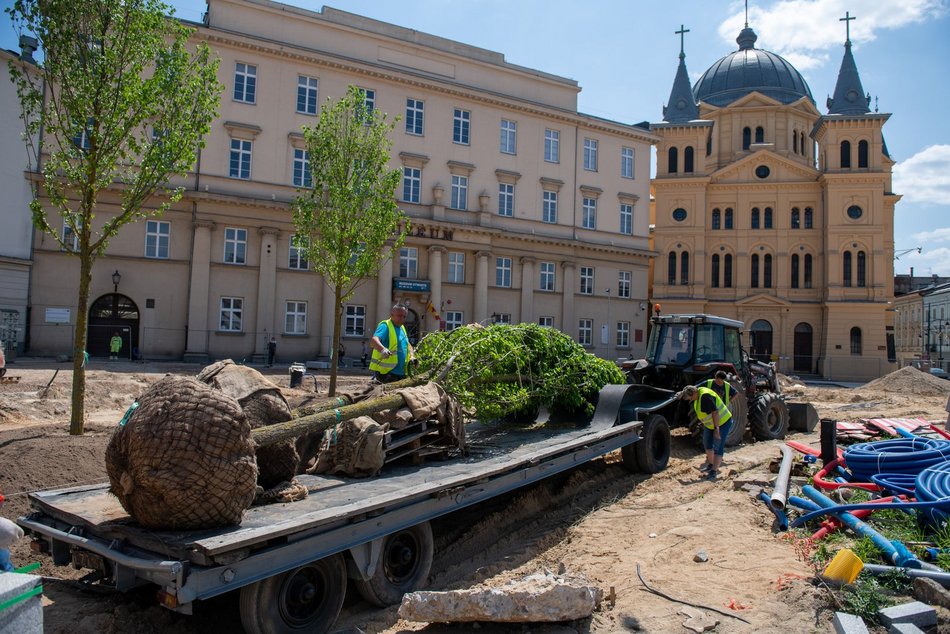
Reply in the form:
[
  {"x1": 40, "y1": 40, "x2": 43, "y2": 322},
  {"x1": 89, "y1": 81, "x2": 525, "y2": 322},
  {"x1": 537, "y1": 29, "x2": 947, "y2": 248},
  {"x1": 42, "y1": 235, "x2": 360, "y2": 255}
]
[{"x1": 0, "y1": 0, "x2": 950, "y2": 275}]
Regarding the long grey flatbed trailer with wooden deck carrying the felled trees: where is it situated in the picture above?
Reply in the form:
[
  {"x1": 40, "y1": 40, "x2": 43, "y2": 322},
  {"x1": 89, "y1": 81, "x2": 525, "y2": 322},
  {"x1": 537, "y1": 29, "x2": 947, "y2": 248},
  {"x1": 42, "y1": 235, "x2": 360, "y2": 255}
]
[{"x1": 18, "y1": 385, "x2": 672, "y2": 634}]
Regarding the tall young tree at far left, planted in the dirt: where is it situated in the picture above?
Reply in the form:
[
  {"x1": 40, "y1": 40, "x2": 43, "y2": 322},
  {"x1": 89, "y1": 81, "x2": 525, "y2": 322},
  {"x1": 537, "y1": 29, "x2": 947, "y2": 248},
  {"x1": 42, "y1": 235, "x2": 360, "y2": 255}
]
[{"x1": 7, "y1": 0, "x2": 223, "y2": 434}]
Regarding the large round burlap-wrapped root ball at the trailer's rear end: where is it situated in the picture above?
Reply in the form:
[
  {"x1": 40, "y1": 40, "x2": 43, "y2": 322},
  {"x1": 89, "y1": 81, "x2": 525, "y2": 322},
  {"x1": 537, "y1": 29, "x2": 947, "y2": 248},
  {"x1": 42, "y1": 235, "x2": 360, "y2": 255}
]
[{"x1": 106, "y1": 376, "x2": 257, "y2": 530}]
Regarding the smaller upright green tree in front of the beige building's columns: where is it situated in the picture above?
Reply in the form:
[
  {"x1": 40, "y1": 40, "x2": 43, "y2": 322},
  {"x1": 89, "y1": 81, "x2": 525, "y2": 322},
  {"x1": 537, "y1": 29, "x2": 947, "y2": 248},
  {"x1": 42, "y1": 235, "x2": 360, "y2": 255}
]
[{"x1": 293, "y1": 81, "x2": 409, "y2": 396}]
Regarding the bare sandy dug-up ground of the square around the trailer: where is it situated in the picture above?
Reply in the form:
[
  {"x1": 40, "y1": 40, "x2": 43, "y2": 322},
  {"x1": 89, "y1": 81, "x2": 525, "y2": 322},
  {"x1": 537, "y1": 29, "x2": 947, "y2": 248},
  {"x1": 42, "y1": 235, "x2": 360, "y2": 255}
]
[{"x1": 0, "y1": 360, "x2": 950, "y2": 634}]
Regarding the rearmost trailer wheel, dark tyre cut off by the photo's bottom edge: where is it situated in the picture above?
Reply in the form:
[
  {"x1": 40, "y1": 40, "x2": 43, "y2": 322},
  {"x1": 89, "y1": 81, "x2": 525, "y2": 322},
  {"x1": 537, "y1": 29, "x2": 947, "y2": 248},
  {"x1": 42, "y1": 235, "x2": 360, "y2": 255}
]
[{"x1": 240, "y1": 554, "x2": 346, "y2": 634}]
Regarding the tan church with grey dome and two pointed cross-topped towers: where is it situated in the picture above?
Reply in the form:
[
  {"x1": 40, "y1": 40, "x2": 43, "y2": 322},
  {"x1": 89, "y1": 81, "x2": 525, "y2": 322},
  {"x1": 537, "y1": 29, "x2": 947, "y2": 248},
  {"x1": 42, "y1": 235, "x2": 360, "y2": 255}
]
[{"x1": 650, "y1": 15, "x2": 900, "y2": 381}]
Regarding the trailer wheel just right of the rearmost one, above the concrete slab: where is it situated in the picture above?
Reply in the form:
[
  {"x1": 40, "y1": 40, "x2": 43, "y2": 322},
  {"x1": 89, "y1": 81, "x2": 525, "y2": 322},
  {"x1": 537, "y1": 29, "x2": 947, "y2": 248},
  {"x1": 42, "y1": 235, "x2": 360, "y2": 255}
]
[{"x1": 354, "y1": 522, "x2": 434, "y2": 607}]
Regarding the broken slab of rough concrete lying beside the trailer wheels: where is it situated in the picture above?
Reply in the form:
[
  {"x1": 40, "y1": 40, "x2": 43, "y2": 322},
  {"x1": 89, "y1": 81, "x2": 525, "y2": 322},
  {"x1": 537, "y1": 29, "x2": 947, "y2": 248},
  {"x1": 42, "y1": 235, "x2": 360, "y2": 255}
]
[{"x1": 399, "y1": 573, "x2": 603, "y2": 623}]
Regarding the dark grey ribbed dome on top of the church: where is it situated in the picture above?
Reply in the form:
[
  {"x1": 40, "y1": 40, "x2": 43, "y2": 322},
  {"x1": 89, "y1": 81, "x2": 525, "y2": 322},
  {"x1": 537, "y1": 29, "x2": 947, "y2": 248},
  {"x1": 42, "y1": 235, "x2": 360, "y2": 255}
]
[{"x1": 693, "y1": 26, "x2": 815, "y2": 107}]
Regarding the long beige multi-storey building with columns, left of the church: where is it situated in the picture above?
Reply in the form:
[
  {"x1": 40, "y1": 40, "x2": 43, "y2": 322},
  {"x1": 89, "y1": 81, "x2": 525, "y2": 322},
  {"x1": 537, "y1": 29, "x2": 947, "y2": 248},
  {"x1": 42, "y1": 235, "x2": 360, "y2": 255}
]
[{"x1": 30, "y1": 0, "x2": 657, "y2": 361}]
